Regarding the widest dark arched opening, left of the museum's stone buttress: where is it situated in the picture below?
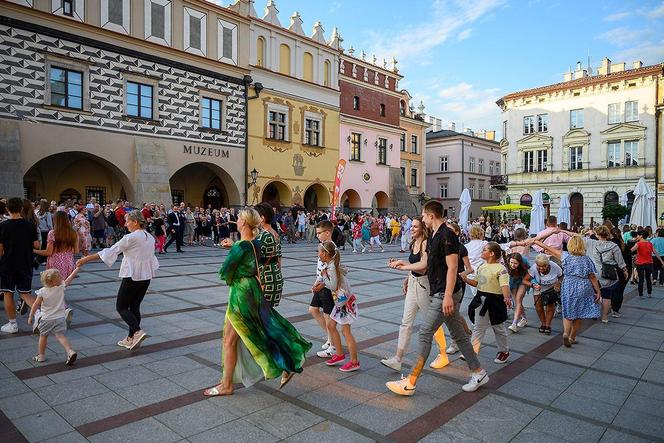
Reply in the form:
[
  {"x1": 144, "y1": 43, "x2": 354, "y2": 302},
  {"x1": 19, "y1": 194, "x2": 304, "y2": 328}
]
[{"x1": 23, "y1": 151, "x2": 135, "y2": 204}]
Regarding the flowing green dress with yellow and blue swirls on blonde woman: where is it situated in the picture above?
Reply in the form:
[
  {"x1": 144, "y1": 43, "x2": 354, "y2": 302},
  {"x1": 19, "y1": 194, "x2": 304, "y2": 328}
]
[{"x1": 219, "y1": 240, "x2": 311, "y2": 386}]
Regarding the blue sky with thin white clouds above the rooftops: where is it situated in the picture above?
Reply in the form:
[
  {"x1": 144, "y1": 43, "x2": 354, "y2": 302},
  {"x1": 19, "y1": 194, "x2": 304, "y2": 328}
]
[{"x1": 213, "y1": 0, "x2": 664, "y2": 132}]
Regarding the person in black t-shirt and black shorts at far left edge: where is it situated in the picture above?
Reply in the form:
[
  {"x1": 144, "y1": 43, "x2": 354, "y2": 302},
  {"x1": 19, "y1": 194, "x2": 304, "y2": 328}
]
[{"x1": 0, "y1": 197, "x2": 40, "y2": 334}]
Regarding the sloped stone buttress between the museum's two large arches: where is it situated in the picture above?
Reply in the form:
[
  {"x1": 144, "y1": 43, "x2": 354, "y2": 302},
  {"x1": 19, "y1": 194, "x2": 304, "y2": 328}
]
[{"x1": 133, "y1": 137, "x2": 172, "y2": 206}]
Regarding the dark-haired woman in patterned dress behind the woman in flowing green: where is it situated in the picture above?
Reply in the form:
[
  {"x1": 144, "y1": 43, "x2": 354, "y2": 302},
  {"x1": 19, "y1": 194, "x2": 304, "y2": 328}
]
[{"x1": 254, "y1": 203, "x2": 284, "y2": 307}]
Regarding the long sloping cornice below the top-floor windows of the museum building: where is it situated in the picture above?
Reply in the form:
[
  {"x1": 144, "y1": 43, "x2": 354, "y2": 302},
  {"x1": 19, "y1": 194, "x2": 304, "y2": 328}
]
[{"x1": 0, "y1": 7, "x2": 249, "y2": 85}]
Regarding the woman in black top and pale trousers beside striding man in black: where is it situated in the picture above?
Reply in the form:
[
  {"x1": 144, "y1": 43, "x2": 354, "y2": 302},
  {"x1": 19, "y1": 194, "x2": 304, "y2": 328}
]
[{"x1": 380, "y1": 217, "x2": 449, "y2": 372}]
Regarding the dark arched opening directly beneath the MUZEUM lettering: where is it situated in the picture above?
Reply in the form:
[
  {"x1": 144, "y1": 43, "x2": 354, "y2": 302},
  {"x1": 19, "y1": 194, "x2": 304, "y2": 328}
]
[{"x1": 169, "y1": 162, "x2": 242, "y2": 209}]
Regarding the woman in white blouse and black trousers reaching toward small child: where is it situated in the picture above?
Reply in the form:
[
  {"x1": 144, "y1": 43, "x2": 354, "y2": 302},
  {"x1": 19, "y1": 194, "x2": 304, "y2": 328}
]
[{"x1": 76, "y1": 211, "x2": 159, "y2": 349}]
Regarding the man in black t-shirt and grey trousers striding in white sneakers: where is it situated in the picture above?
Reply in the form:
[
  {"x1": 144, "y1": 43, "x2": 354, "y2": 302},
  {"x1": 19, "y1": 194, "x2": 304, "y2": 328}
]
[{"x1": 386, "y1": 201, "x2": 489, "y2": 396}]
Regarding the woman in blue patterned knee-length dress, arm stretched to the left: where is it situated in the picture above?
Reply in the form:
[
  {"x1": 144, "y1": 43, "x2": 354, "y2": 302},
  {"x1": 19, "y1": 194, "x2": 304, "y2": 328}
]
[{"x1": 535, "y1": 237, "x2": 601, "y2": 348}]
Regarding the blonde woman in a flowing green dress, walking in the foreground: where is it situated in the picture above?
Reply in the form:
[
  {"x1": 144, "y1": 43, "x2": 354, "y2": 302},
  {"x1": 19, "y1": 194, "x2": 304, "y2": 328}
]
[{"x1": 203, "y1": 208, "x2": 311, "y2": 397}]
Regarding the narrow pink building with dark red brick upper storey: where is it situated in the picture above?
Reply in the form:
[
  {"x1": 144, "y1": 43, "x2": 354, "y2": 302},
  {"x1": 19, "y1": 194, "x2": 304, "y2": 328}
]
[{"x1": 339, "y1": 48, "x2": 413, "y2": 213}]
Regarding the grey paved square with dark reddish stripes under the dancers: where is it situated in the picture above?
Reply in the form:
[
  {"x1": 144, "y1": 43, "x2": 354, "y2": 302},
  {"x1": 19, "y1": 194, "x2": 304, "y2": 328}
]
[{"x1": 0, "y1": 244, "x2": 664, "y2": 443}]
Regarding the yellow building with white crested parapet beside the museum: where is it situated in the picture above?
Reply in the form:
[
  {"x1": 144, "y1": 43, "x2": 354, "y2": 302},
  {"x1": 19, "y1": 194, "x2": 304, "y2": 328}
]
[{"x1": 237, "y1": 0, "x2": 339, "y2": 209}]
